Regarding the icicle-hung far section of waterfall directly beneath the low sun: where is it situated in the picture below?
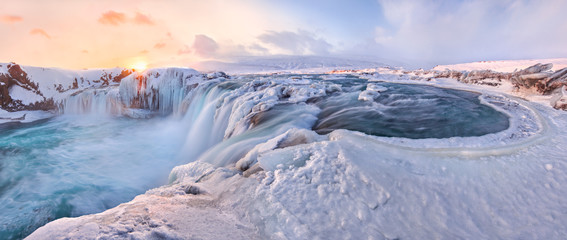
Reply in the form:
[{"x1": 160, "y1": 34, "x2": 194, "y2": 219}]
[{"x1": 60, "y1": 68, "x2": 204, "y2": 117}]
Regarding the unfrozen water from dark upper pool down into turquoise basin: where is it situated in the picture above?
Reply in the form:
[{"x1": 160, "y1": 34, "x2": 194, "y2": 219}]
[{"x1": 0, "y1": 75, "x2": 509, "y2": 239}]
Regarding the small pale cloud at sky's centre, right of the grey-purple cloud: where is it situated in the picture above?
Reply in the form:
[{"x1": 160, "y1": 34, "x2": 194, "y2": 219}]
[{"x1": 258, "y1": 29, "x2": 333, "y2": 55}]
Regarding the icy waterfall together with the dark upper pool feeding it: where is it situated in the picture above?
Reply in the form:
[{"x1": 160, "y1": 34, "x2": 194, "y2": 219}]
[{"x1": 58, "y1": 69, "x2": 530, "y2": 169}]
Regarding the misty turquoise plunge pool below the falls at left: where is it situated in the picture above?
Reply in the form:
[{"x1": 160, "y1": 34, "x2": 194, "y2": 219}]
[{"x1": 0, "y1": 115, "x2": 186, "y2": 239}]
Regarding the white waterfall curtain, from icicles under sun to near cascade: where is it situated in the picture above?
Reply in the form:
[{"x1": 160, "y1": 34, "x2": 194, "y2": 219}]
[{"x1": 58, "y1": 69, "x2": 326, "y2": 166}]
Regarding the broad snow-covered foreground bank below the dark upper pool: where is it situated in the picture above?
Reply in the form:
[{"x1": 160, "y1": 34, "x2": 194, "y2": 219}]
[{"x1": 30, "y1": 99, "x2": 567, "y2": 239}]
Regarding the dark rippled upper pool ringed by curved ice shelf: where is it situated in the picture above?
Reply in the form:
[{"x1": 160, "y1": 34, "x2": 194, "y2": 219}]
[{"x1": 313, "y1": 82, "x2": 509, "y2": 139}]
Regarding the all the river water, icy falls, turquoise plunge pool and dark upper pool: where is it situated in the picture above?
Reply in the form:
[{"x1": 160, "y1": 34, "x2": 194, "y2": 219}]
[{"x1": 0, "y1": 69, "x2": 520, "y2": 239}]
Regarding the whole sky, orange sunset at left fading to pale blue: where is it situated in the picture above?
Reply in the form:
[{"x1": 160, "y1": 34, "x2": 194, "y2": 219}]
[{"x1": 0, "y1": 0, "x2": 567, "y2": 69}]
